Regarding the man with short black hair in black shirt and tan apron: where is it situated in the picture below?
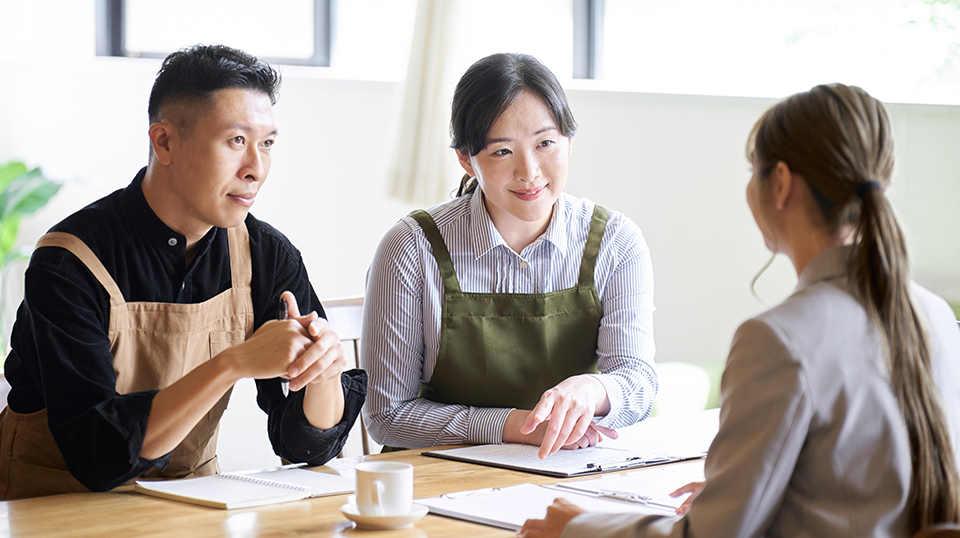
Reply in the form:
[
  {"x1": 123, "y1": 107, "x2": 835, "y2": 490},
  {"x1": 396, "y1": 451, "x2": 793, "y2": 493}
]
[{"x1": 0, "y1": 45, "x2": 366, "y2": 499}]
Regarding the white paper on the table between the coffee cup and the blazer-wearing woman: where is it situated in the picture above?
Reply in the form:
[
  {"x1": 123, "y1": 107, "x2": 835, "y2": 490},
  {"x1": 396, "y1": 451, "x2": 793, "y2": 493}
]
[{"x1": 415, "y1": 484, "x2": 673, "y2": 531}]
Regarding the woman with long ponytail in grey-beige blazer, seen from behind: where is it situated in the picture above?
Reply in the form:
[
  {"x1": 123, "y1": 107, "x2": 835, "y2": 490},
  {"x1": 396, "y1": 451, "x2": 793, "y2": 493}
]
[{"x1": 520, "y1": 84, "x2": 960, "y2": 538}]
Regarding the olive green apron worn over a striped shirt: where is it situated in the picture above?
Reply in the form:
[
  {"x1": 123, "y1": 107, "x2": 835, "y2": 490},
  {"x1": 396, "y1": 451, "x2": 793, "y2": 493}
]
[{"x1": 411, "y1": 206, "x2": 610, "y2": 409}]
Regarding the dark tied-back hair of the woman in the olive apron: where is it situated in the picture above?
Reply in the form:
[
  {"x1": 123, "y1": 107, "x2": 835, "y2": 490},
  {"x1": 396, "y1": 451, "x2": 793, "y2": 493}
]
[{"x1": 450, "y1": 53, "x2": 577, "y2": 196}]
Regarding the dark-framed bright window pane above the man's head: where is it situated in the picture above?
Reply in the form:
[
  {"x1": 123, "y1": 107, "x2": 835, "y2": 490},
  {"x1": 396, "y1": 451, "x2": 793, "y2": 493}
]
[{"x1": 124, "y1": 0, "x2": 314, "y2": 59}]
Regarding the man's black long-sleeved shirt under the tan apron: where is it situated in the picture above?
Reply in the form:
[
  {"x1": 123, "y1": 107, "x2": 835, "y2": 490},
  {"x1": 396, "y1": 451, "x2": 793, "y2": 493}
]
[{"x1": 5, "y1": 169, "x2": 366, "y2": 490}]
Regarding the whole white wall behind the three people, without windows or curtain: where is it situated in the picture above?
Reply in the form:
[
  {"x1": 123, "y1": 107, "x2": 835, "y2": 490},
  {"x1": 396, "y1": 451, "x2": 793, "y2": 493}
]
[{"x1": 0, "y1": 31, "x2": 960, "y2": 464}]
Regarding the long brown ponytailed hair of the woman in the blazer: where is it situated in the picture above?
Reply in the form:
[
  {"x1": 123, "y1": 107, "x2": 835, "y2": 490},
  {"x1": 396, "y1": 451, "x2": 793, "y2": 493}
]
[{"x1": 747, "y1": 84, "x2": 960, "y2": 531}]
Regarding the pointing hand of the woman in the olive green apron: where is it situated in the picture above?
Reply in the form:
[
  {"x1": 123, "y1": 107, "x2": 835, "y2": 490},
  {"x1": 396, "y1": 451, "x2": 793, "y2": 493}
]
[{"x1": 520, "y1": 375, "x2": 617, "y2": 459}]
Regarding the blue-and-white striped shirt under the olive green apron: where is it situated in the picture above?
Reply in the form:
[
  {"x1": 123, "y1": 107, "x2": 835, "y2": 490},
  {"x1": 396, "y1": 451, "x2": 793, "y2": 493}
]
[{"x1": 361, "y1": 190, "x2": 657, "y2": 448}]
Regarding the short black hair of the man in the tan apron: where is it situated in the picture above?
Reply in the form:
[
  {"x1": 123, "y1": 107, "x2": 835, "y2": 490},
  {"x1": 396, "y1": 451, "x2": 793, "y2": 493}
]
[{"x1": 147, "y1": 45, "x2": 280, "y2": 123}]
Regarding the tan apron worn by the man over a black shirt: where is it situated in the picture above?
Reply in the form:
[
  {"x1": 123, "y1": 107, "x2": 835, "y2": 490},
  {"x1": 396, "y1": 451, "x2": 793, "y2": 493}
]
[{"x1": 0, "y1": 224, "x2": 253, "y2": 500}]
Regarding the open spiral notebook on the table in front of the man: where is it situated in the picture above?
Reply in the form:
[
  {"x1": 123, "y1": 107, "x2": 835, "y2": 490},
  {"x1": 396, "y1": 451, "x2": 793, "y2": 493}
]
[{"x1": 134, "y1": 469, "x2": 356, "y2": 510}]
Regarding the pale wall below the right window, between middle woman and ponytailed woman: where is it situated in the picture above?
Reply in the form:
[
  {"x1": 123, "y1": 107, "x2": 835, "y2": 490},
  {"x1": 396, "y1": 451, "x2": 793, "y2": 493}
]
[{"x1": 567, "y1": 90, "x2": 960, "y2": 361}]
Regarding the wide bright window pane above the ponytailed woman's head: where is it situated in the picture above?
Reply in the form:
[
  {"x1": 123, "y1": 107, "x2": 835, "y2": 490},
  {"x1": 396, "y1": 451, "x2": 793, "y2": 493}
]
[{"x1": 604, "y1": 0, "x2": 960, "y2": 104}]
